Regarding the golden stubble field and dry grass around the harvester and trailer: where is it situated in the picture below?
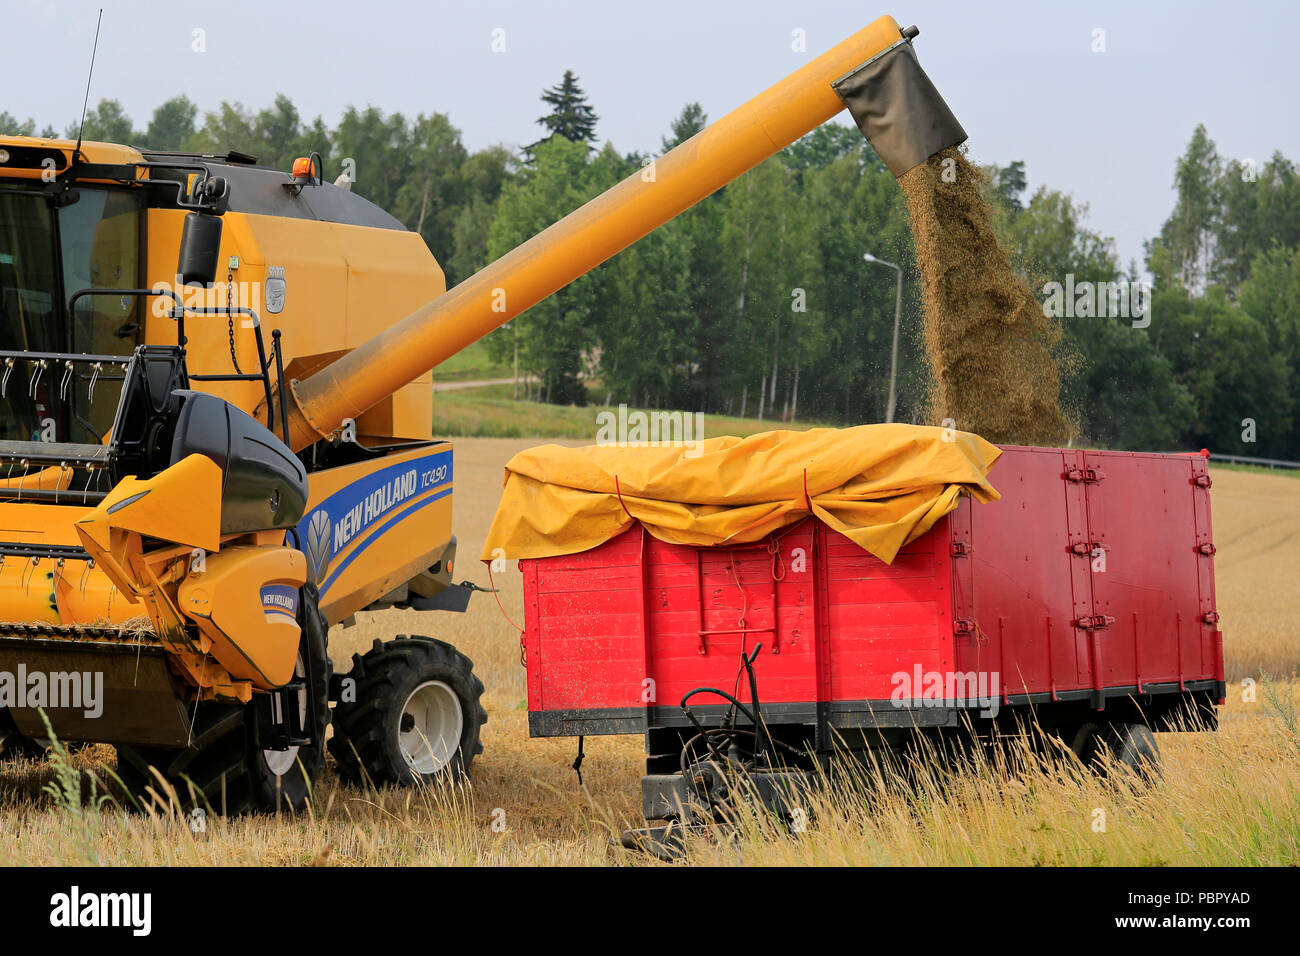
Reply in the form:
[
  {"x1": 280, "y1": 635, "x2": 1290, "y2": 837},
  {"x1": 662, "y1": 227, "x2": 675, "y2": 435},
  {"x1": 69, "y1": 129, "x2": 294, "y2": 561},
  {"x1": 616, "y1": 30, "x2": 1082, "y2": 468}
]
[{"x1": 0, "y1": 440, "x2": 1300, "y2": 865}]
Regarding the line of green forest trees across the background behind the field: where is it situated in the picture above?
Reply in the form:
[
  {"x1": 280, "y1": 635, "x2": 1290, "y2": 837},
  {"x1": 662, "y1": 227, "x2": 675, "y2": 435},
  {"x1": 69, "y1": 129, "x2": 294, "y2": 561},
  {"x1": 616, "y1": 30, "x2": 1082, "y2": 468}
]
[{"x1": 0, "y1": 80, "x2": 1300, "y2": 459}]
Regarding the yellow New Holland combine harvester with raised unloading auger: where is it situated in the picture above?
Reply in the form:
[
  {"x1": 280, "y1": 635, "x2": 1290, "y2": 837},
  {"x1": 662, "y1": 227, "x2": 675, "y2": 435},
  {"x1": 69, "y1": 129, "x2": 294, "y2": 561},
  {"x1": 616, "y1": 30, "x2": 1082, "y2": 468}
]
[{"x1": 0, "y1": 17, "x2": 965, "y2": 812}]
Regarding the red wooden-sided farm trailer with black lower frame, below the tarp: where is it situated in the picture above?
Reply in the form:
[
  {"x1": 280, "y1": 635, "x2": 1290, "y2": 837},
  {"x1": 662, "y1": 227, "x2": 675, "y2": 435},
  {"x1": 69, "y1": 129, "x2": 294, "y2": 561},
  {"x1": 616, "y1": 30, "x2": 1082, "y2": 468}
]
[{"x1": 520, "y1": 447, "x2": 1225, "y2": 817}]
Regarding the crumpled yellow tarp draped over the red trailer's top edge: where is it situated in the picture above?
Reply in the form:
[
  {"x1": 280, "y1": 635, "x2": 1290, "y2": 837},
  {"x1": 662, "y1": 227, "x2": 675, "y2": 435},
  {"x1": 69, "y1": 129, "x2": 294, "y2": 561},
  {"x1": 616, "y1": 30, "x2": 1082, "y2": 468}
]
[{"x1": 482, "y1": 424, "x2": 1001, "y2": 562}]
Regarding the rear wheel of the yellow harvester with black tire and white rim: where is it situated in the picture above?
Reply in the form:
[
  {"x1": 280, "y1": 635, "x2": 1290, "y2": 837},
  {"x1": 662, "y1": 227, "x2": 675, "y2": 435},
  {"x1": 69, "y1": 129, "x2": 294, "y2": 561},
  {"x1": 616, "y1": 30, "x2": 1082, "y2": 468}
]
[{"x1": 329, "y1": 635, "x2": 488, "y2": 786}]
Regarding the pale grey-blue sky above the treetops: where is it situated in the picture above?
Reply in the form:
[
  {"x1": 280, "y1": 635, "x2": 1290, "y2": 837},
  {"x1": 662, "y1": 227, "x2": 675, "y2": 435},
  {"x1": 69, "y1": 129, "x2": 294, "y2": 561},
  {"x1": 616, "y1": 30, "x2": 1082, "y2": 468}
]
[{"x1": 0, "y1": 0, "x2": 1300, "y2": 267}]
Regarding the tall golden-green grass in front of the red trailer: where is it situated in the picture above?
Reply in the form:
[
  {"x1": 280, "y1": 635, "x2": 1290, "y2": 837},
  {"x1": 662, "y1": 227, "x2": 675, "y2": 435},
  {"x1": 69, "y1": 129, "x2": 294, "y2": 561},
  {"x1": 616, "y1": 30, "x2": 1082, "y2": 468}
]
[{"x1": 690, "y1": 683, "x2": 1300, "y2": 866}]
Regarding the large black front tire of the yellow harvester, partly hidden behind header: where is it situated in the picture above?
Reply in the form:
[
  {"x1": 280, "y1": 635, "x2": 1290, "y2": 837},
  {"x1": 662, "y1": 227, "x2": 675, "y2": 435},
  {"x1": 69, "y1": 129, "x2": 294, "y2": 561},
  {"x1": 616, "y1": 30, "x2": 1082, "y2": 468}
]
[{"x1": 117, "y1": 584, "x2": 330, "y2": 816}]
